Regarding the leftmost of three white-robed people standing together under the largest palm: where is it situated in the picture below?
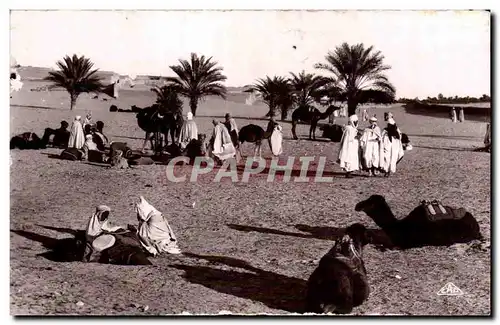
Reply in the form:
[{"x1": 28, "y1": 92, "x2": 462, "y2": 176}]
[{"x1": 338, "y1": 115, "x2": 359, "y2": 178}]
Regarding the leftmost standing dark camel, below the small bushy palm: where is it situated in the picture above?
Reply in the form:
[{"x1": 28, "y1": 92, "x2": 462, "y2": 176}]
[{"x1": 136, "y1": 104, "x2": 182, "y2": 152}]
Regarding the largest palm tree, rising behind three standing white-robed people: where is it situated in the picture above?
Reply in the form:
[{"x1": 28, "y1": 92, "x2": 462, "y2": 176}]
[{"x1": 314, "y1": 43, "x2": 396, "y2": 116}]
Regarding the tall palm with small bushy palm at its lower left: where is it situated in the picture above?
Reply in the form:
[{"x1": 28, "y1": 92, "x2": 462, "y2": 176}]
[{"x1": 166, "y1": 53, "x2": 227, "y2": 116}]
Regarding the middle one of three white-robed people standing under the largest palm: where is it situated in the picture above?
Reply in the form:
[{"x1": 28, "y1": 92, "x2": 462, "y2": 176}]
[{"x1": 360, "y1": 117, "x2": 382, "y2": 176}]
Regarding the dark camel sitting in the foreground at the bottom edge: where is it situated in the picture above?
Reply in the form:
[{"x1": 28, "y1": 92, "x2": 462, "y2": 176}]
[{"x1": 305, "y1": 223, "x2": 370, "y2": 314}]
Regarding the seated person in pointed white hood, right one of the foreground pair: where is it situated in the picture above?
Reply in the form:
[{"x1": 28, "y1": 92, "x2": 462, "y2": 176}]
[{"x1": 135, "y1": 196, "x2": 181, "y2": 256}]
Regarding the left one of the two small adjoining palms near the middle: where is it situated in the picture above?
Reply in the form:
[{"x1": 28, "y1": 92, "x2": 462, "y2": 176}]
[{"x1": 245, "y1": 76, "x2": 294, "y2": 120}]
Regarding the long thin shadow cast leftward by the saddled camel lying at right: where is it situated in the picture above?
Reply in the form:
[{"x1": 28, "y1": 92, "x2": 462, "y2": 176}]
[{"x1": 227, "y1": 224, "x2": 397, "y2": 251}]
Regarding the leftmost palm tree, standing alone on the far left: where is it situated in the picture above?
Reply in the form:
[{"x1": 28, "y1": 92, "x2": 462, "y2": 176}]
[{"x1": 44, "y1": 54, "x2": 104, "y2": 110}]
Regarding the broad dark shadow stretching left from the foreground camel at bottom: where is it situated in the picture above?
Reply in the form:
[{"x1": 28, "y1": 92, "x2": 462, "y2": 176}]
[{"x1": 169, "y1": 253, "x2": 307, "y2": 313}]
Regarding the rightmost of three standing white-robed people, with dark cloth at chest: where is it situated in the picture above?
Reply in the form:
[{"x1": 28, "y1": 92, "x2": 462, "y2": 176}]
[{"x1": 380, "y1": 118, "x2": 404, "y2": 177}]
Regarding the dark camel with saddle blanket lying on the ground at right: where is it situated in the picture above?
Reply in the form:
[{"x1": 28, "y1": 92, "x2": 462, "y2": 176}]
[{"x1": 355, "y1": 195, "x2": 483, "y2": 249}]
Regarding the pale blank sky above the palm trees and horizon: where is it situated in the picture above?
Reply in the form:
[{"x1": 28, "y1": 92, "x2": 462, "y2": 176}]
[{"x1": 10, "y1": 11, "x2": 491, "y2": 98}]
